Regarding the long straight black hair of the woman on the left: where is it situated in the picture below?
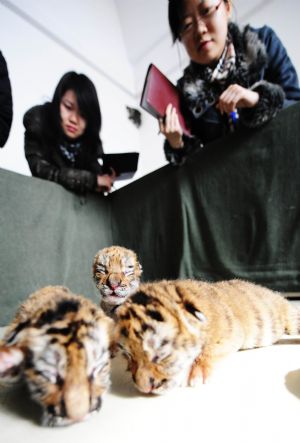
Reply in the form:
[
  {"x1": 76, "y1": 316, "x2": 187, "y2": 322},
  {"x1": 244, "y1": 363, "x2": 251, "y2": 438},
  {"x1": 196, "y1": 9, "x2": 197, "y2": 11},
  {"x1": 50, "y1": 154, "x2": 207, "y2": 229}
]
[{"x1": 48, "y1": 71, "x2": 103, "y2": 156}]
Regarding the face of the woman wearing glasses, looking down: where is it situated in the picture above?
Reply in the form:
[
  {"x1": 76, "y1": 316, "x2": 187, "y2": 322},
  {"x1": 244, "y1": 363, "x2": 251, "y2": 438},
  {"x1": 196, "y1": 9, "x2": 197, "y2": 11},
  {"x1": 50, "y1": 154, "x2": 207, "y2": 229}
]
[{"x1": 180, "y1": 0, "x2": 231, "y2": 66}]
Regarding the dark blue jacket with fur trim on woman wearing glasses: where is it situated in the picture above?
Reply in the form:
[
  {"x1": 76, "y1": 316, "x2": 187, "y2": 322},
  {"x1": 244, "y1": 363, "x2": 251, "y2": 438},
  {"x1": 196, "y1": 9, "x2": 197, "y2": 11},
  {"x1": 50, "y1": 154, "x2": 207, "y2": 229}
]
[{"x1": 164, "y1": 23, "x2": 300, "y2": 164}]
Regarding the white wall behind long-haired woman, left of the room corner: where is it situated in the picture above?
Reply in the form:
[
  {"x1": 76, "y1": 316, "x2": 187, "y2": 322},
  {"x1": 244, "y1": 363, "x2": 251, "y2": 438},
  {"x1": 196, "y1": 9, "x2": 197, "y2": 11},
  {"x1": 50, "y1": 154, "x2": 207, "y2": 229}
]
[{"x1": 0, "y1": 0, "x2": 140, "y2": 188}]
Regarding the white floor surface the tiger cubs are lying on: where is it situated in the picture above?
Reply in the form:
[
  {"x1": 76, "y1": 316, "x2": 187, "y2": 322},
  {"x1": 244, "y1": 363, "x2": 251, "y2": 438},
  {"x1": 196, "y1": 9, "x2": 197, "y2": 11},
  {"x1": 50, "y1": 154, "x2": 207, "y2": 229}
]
[{"x1": 0, "y1": 324, "x2": 300, "y2": 443}]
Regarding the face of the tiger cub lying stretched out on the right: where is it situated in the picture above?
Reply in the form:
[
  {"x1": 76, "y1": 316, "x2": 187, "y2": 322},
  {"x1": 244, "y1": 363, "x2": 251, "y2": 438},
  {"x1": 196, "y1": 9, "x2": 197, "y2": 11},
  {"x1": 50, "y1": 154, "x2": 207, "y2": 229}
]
[{"x1": 116, "y1": 302, "x2": 203, "y2": 394}]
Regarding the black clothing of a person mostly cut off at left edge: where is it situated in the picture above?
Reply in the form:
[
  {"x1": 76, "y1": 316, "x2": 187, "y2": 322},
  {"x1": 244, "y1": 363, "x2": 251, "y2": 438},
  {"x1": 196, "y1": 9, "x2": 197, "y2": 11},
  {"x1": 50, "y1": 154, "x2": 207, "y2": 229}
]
[{"x1": 0, "y1": 52, "x2": 13, "y2": 148}]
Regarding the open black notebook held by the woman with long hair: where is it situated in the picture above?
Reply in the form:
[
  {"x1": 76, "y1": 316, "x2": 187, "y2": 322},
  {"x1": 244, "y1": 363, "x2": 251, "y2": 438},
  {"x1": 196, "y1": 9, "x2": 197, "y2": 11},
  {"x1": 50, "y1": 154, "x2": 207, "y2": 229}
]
[{"x1": 102, "y1": 152, "x2": 139, "y2": 180}]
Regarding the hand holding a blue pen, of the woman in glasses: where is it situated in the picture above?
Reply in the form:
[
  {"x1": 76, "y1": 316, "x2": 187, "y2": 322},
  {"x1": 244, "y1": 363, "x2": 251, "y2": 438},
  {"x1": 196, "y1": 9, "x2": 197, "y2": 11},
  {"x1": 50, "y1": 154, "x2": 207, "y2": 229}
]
[{"x1": 217, "y1": 85, "x2": 259, "y2": 114}]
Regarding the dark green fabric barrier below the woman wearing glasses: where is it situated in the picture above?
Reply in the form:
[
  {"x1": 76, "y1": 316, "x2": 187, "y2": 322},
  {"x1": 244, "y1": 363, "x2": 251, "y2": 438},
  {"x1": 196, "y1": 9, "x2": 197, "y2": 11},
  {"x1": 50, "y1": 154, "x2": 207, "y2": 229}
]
[{"x1": 111, "y1": 104, "x2": 300, "y2": 291}]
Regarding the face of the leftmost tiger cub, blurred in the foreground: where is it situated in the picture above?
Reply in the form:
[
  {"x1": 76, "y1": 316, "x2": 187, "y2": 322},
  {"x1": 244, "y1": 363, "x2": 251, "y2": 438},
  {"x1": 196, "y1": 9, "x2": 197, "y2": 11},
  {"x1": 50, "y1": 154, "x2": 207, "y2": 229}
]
[{"x1": 0, "y1": 319, "x2": 110, "y2": 426}]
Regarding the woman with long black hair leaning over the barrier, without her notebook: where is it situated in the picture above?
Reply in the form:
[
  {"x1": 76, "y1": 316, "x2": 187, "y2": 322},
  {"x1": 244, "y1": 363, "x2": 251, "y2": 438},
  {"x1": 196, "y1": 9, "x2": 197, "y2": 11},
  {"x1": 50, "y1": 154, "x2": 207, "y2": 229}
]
[{"x1": 23, "y1": 72, "x2": 115, "y2": 194}]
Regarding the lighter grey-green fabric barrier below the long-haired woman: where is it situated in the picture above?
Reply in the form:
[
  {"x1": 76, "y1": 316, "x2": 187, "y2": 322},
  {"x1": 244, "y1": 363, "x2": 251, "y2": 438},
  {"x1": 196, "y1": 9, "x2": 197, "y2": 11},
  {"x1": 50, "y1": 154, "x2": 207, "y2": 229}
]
[{"x1": 0, "y1": 169, "x2": 112, "y2": 325}]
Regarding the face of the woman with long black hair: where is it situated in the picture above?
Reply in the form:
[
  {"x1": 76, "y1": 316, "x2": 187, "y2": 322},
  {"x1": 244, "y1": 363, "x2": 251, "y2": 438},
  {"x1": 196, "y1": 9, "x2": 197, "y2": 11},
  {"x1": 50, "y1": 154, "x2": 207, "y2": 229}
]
[{"x1": 60, "y1": 89, "x2": 86, "y2": 139}]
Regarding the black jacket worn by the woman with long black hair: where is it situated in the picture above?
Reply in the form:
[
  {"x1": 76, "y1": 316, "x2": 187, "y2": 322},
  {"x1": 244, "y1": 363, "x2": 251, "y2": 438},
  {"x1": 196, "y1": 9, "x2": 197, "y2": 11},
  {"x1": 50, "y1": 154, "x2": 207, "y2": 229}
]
[{"x1": 23, "y1": 103, "x2": 102, "y2": 194}]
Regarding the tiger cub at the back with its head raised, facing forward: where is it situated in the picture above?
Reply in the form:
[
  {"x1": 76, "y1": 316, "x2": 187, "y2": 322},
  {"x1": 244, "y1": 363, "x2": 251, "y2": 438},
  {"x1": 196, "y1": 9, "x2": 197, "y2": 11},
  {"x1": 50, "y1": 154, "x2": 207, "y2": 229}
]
[{"x1": 93, "y1": 246, "x2": 142, "y2": 316}]
